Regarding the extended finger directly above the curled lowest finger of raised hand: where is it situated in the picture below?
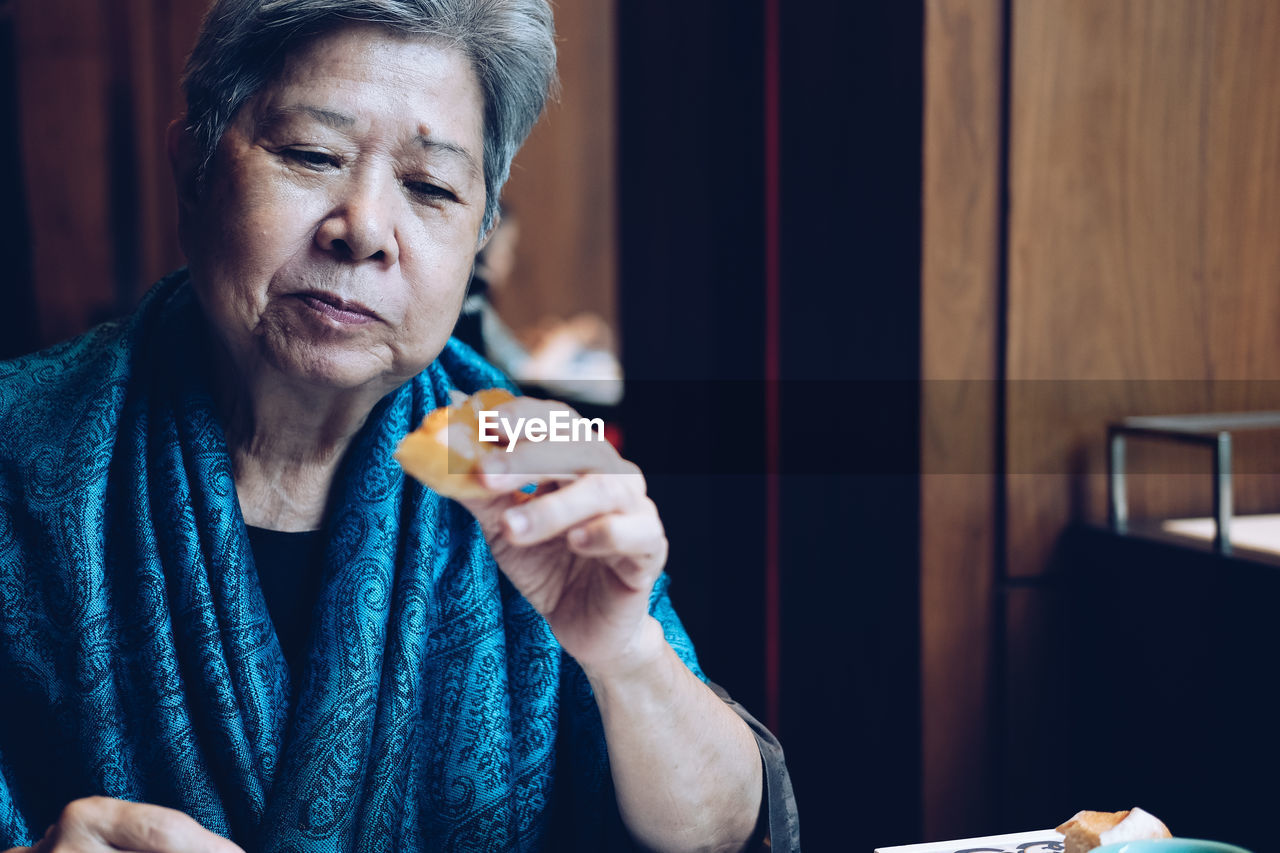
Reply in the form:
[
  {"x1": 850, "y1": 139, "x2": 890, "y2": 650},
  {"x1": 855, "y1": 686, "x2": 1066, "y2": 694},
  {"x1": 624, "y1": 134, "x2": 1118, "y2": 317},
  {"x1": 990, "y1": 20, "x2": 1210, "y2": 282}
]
[{"x1": 502, "y1": 474, "x2": 645, "y2": 546}]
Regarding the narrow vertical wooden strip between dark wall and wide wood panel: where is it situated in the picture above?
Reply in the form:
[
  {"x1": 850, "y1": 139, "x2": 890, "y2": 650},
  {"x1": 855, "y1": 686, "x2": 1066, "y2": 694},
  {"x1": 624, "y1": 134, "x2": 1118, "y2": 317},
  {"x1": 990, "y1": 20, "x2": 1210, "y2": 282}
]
[{"x1": 920, "y1": 0, "x2": 1002, "y2": 839}]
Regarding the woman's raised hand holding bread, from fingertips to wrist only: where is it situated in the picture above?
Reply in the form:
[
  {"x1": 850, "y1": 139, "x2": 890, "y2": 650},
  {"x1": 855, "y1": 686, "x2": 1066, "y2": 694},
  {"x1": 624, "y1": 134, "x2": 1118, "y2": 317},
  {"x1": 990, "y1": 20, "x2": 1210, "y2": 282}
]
[{"x1": 462, "y1": 397, "x2": 667, "y2": 671}]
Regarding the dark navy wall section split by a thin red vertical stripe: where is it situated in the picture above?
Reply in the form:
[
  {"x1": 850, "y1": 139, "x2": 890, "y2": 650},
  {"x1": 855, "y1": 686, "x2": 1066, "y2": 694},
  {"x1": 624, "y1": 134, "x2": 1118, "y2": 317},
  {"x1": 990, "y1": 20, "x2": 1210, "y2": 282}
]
[{"x1": 618, "y1": 0, "x2": 923, "y2": 850}]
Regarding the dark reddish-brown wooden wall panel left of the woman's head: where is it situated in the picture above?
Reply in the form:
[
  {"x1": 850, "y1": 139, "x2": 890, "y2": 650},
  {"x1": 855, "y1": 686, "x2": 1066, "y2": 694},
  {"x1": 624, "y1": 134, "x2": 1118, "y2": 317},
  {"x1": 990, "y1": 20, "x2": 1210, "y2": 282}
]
[{"x1": 13, "y1": 0, "x2": 207, "y2": 345}]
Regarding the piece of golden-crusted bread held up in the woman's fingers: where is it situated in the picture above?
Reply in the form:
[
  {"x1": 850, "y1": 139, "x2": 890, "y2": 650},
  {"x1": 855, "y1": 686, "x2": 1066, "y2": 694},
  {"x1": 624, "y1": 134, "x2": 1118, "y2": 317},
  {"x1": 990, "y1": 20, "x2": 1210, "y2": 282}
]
[{"x1": 396, "y1": 388, "x2": 515, "y2": 498}]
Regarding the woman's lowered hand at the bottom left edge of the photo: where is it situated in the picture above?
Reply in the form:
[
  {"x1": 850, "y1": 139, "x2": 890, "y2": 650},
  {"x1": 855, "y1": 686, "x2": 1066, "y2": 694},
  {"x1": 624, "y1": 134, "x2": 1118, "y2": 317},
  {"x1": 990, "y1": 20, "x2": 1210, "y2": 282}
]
[{"x1": 6, "y1": 797, "x2": 244, "y2": 853}]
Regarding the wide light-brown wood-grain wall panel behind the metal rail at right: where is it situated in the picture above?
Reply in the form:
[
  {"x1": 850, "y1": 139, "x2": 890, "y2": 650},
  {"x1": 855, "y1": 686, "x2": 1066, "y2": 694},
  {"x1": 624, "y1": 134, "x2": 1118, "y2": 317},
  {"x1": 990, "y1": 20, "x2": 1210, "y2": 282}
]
[{"x1": 1006, "y1": 0, "x2": 1280, "y2": 575}]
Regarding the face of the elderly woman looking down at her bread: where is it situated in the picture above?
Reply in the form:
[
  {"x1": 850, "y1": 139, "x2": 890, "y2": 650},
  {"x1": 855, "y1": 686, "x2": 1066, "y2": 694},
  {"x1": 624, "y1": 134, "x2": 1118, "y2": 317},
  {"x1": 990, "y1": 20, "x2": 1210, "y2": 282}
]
[{"x1": 182, "y1": 26, "x2": 485, "y2": 391}]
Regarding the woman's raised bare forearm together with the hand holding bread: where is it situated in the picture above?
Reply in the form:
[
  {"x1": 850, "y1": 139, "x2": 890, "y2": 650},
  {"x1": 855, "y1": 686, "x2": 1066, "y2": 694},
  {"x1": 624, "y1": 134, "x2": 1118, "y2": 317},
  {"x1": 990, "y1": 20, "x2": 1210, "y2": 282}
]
[{"x1": 462, "y1": 398, "x2": 764, "y2": 850}]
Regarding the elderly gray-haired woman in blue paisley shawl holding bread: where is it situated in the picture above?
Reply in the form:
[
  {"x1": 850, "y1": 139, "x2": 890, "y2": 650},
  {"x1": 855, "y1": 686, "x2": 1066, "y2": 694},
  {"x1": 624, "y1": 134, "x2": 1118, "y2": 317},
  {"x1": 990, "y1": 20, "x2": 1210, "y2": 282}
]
[{"x1": 0, "y1": 0, "x2": 795, "y2": 852}]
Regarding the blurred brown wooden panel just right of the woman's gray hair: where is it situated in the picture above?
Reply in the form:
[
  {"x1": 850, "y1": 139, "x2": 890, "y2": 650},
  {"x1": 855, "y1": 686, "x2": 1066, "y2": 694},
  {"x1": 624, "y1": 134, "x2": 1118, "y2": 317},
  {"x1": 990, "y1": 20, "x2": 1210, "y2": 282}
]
[{"x1": 499, "y1": 0, "x2": 614, "y2": 328}]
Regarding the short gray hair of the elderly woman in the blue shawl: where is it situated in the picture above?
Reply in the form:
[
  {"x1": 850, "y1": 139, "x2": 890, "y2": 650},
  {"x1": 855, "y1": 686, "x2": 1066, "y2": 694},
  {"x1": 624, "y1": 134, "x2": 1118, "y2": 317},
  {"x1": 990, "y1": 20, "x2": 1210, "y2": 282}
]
[{"x1": 183, "y1": 0, "x2": 557, "y2": 233}]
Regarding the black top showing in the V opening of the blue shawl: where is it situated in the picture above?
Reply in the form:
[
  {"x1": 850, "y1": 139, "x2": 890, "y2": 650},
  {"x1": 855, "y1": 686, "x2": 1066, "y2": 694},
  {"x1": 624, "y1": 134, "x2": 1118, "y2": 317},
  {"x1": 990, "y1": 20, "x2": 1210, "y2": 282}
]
[{"x1": 248, "y1": 528, "x2": 325, "y2": 683}]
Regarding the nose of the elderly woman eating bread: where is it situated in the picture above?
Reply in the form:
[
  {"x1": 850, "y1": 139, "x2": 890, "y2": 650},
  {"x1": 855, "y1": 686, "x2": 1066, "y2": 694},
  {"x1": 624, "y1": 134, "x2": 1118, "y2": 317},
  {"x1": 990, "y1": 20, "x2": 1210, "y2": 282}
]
[{"x1": 316, "y1": 173, "x2": 399, "y2": 266}]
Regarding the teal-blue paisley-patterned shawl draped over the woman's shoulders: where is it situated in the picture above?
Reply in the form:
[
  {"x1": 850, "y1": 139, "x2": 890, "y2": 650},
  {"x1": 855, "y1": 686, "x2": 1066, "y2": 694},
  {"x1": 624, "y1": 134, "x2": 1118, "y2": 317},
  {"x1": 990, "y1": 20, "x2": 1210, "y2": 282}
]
[{"x1": 0, "y1": 272, "x2": 705, "y2": 850}]
